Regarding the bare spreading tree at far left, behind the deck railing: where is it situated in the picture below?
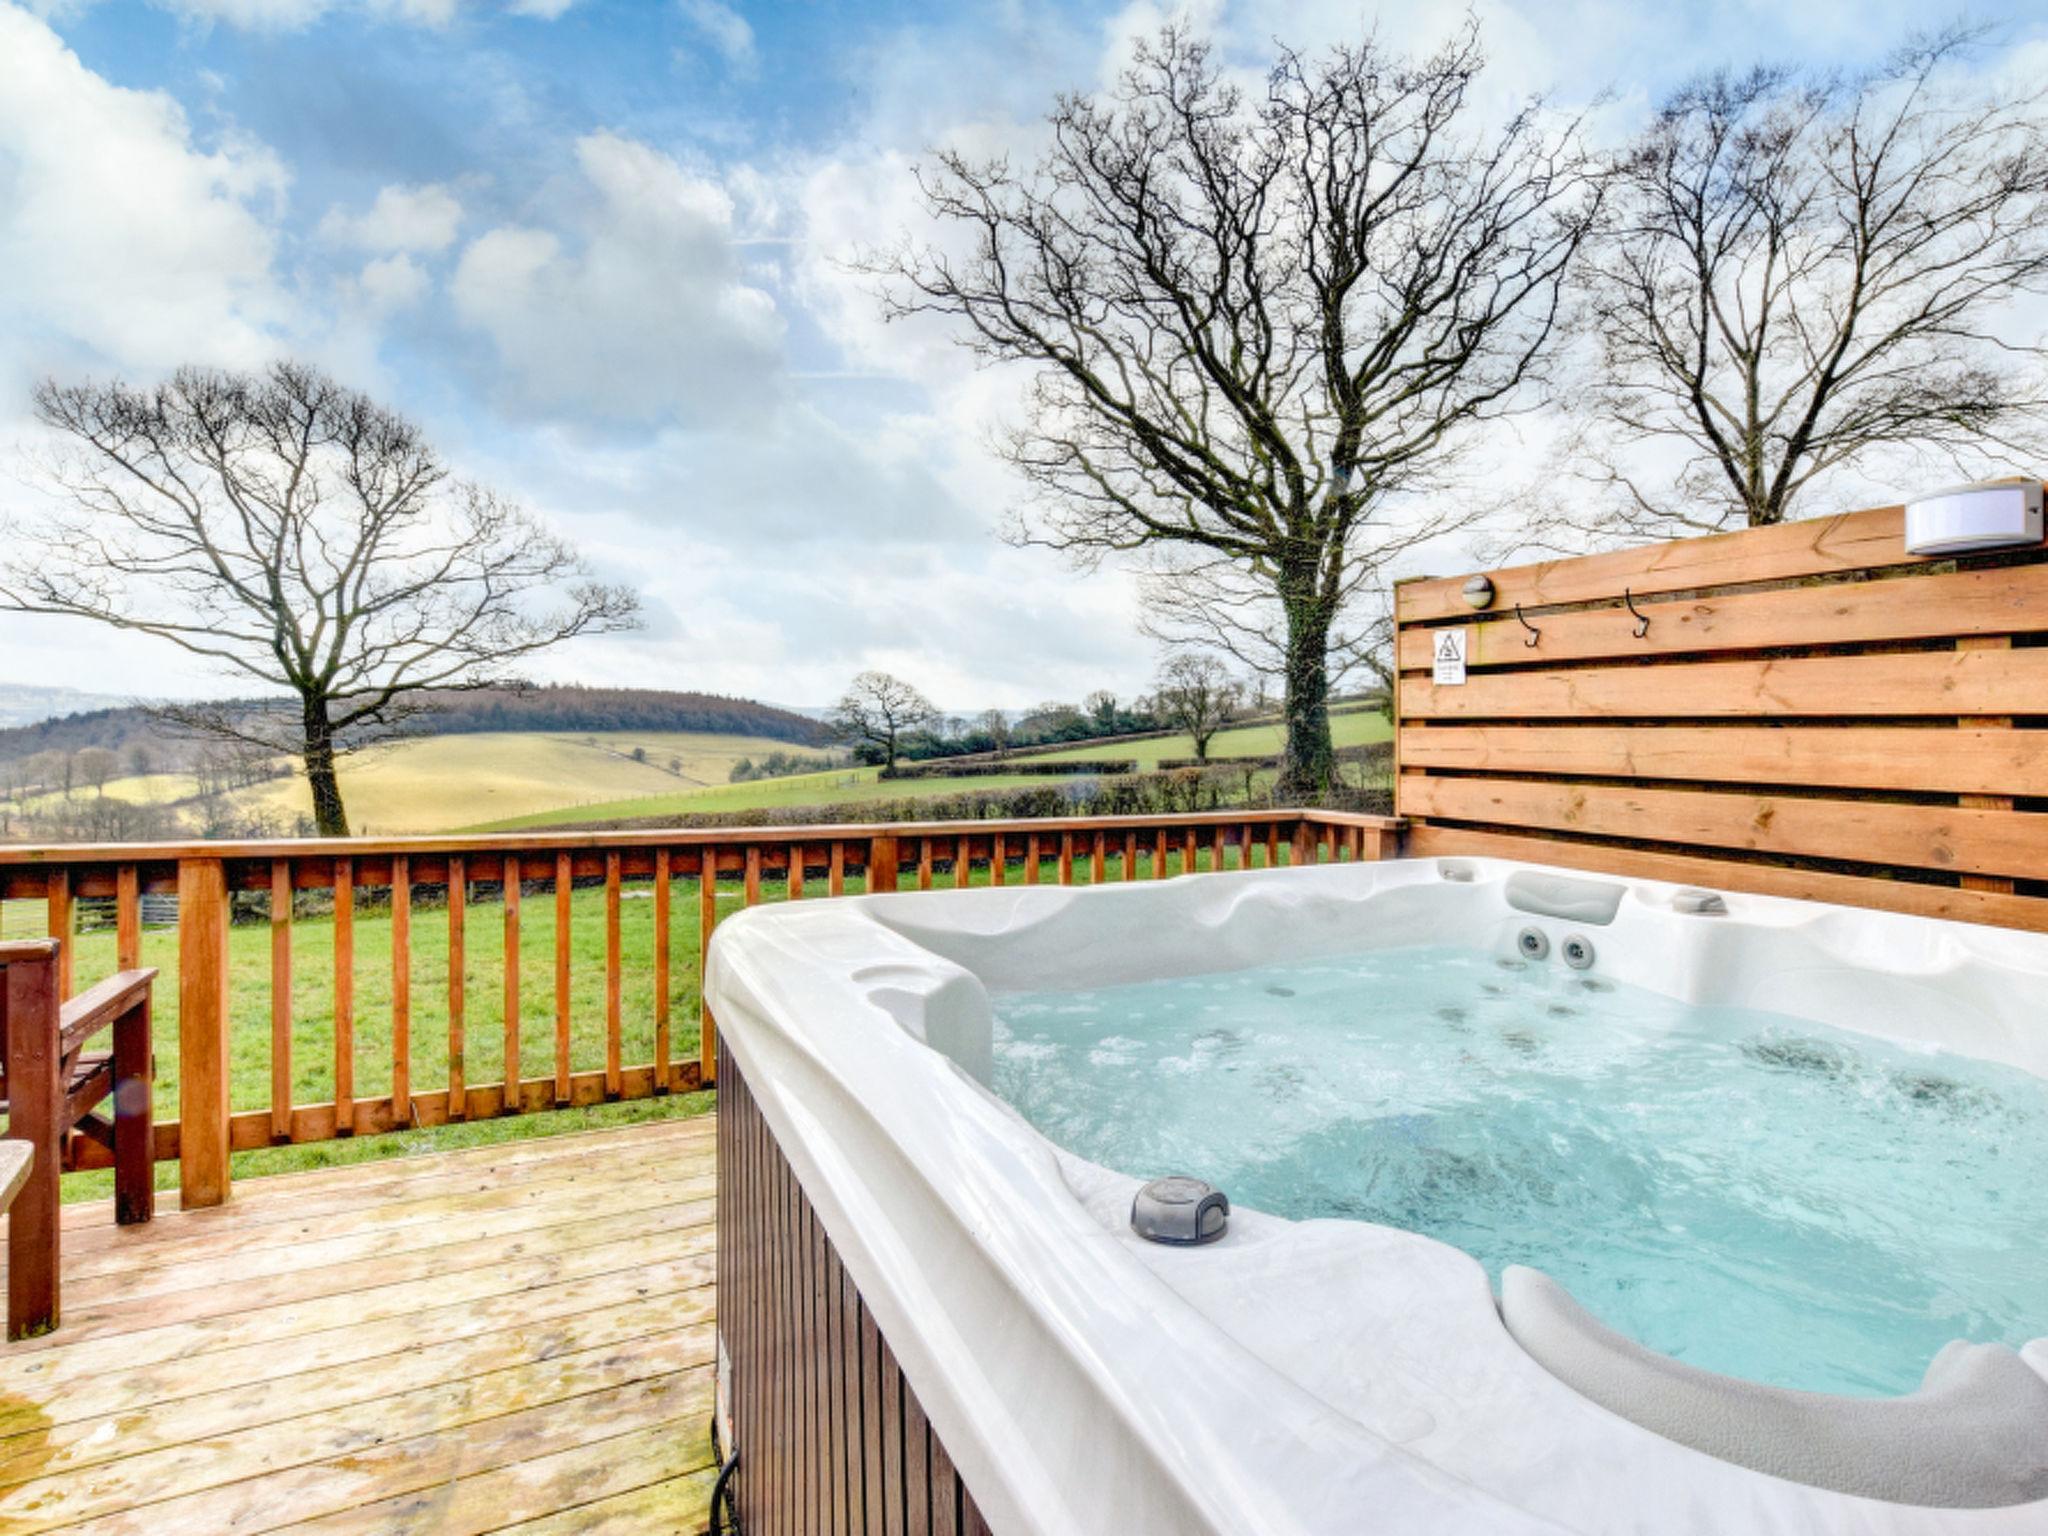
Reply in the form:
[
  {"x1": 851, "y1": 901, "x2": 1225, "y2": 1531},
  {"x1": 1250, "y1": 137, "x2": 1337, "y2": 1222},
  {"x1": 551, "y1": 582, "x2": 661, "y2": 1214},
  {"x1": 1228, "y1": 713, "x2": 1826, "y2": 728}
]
[{"x1": 0, "y1": 362, "x2": 637, "y2": 836}]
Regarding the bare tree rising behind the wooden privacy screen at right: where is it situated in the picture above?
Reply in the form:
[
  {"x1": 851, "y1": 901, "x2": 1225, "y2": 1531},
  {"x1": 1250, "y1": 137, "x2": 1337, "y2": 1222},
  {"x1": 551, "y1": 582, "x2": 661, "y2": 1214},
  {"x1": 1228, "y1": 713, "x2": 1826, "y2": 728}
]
[{"x1": 1565, "y1": 29, "x2": 2048, "y2": 537}]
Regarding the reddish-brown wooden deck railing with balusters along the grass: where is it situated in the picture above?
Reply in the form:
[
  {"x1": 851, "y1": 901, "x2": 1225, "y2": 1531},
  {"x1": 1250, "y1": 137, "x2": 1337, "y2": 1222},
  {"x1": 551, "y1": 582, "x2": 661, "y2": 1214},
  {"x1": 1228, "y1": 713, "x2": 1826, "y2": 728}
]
[{"x1": 0, "y1": 809, "x2": 1399, "y2": 1206}]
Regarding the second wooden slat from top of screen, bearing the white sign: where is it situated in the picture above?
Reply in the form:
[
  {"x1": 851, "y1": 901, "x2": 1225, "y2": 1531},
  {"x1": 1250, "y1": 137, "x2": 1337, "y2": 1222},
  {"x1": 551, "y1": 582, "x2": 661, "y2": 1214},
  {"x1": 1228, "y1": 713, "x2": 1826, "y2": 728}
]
[{"x1": 1399, "y1": 565, "x2": 2048, "y2": 670}]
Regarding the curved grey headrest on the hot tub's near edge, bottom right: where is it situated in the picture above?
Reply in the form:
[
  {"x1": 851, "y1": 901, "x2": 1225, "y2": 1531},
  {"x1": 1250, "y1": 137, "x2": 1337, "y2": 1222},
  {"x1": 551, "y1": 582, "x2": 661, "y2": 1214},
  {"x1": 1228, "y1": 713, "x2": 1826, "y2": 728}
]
[{"x1": 1501, "y1": 1266, "x2": 2048, "y2": 1509}]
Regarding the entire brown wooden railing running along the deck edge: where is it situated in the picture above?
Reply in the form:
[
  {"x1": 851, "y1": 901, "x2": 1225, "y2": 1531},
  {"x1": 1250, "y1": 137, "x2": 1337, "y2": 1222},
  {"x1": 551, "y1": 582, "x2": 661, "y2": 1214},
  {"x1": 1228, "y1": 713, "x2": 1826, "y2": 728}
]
[{"x1": 0, "y1": 809, "x2": 1397, "y2": 1204}]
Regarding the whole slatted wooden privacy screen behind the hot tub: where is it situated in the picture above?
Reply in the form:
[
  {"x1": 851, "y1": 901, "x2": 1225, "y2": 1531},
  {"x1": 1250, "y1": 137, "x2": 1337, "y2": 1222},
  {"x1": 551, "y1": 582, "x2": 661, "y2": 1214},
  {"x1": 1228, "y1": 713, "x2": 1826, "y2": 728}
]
[{"x1": 1395, "y1": 506, "x2": 2048, "y2": 930}]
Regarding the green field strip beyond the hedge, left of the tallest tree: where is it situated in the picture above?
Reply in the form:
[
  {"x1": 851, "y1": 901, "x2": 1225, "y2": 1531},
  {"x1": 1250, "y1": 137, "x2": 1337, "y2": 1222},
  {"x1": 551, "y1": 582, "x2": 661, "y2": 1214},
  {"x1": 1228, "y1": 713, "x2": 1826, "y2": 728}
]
[{"x1": 463, "y1": 711, "x2": 1391, "y2": 831}]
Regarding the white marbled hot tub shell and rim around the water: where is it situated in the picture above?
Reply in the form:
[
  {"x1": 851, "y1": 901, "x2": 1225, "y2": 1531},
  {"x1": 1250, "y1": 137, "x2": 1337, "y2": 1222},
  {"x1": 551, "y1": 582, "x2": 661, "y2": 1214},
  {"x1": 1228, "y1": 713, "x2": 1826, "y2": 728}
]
[{"x1": 705, "y1": 860, "x2": 2048, "y2": 1536}]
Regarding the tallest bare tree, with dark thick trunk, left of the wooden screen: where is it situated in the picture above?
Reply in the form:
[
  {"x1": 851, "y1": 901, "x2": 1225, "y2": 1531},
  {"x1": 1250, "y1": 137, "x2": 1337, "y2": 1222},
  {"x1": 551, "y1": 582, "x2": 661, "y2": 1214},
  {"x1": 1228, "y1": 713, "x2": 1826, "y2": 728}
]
[{"x1": 864, "y1": 29, "x2": 1599, "y2": 797}]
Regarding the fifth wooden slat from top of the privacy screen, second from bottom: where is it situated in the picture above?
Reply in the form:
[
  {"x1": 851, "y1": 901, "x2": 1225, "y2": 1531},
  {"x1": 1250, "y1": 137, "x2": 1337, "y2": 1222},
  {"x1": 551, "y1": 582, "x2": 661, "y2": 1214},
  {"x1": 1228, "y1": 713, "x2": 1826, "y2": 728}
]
[{"x1": 1401, "y1": 776, "x2": 2048, "y2": 877}]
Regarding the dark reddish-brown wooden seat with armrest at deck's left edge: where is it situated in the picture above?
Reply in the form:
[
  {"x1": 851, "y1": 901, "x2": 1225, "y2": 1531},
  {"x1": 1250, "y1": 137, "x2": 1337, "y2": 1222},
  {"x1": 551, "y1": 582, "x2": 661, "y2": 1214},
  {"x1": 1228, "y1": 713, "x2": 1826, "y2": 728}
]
[{"x1": 0, "y1": 938, "x2": 156, "y2": 1339}]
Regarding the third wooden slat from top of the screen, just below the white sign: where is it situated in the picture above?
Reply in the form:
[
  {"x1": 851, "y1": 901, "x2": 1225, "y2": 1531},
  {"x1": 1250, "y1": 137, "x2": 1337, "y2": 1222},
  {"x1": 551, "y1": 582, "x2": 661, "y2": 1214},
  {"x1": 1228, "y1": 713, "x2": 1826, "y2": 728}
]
[{"x1": 1401, "y1": 647, "x2": 2048, "y2": 721}]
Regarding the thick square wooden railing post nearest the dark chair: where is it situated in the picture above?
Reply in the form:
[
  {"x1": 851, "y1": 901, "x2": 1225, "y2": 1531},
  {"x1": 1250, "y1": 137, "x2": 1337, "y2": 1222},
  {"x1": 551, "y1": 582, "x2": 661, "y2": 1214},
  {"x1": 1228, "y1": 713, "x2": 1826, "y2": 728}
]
[{"x1": 178, "y1": 858, "x2": 229, "y2": 1210}]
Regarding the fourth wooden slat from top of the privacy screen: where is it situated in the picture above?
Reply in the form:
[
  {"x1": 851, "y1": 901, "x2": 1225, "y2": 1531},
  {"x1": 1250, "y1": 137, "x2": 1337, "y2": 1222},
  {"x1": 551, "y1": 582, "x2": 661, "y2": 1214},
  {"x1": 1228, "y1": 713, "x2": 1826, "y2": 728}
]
[{"x1": 1401, "y1": 725, "x2": 2048, "y2": 795}]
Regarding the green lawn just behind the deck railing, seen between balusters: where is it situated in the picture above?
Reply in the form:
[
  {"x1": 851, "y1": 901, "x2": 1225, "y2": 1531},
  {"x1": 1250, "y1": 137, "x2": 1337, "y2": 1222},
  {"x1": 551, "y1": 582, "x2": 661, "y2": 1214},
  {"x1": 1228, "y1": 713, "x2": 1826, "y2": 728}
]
[{"x1": 0, "y1": 850, "x2": 1277, "y2": 1200}]
